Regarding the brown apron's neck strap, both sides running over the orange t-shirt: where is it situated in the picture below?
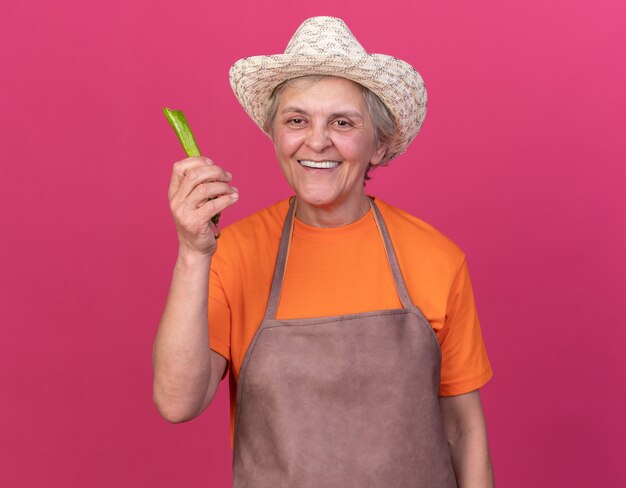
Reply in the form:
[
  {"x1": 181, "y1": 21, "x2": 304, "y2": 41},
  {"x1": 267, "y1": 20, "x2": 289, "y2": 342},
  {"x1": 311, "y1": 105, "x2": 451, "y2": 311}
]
[{"x1": 264, "y1": 198, "x2": 415, "y2": 320}]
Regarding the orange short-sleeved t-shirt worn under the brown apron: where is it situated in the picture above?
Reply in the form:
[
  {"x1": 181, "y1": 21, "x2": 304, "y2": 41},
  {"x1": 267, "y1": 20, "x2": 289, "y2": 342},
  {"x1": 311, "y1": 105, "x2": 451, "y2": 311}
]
[{"x1": 209, "y1": 199, "x2": 492, "y2": 442}]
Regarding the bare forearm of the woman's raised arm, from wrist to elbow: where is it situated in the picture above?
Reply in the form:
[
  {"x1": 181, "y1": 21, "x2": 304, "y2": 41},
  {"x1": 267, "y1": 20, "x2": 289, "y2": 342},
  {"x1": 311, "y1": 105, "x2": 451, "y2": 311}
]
[{"x1": 153, "y1": 253, "x2": 211, "y2": 422}]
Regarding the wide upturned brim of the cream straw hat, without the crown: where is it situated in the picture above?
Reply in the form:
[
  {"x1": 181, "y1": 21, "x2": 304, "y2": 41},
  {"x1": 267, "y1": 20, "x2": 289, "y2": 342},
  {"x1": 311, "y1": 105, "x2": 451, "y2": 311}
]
[{"x1": 230, "y1": 54, "x2": 427, "y2": 160}]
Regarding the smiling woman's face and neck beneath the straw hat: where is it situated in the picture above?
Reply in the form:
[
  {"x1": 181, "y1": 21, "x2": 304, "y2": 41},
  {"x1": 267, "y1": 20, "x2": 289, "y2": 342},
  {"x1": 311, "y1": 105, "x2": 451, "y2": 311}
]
[{"x1": 273, "y1": 77, "x2": 386, "y2": 227}]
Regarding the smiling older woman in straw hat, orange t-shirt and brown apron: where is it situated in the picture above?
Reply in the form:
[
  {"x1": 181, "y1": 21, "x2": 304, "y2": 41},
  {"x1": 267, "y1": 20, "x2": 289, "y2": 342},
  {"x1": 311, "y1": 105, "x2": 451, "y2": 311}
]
[{"x1": 154, "y1": 17, "x2": 493, "y2": 488}]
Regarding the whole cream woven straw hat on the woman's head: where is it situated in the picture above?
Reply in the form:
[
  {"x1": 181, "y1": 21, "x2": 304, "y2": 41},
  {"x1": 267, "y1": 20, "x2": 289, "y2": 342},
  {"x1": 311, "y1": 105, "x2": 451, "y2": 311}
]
[{"x1": 230, "y1": 17, "x2": 426, "y2": 159}]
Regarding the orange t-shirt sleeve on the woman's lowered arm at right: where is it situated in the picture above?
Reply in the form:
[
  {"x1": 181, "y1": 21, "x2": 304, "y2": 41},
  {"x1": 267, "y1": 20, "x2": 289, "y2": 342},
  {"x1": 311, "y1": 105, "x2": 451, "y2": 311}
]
[{"x1": 438, "y1": 259, "x2": 493, "y2": 396}]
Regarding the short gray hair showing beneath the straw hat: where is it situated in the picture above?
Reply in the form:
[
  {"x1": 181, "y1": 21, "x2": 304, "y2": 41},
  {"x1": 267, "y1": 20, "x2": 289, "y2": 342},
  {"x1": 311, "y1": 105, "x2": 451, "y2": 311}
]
[{"x1": 263, "y1": 75, "x2": 397, "y2": 180}]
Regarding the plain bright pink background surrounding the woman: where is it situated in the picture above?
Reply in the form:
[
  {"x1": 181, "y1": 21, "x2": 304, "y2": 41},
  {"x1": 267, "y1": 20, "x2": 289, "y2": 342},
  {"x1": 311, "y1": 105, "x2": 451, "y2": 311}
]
[{"x1": 0, "y1": 0, "x2": 626, "y2": 488}]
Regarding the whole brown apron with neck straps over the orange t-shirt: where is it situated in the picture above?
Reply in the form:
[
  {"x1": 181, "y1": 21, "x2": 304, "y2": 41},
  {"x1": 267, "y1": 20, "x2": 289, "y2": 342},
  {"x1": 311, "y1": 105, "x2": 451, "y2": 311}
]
[{"x1": 233, "y1": 202, "x2": 456, "y2": 488}]
